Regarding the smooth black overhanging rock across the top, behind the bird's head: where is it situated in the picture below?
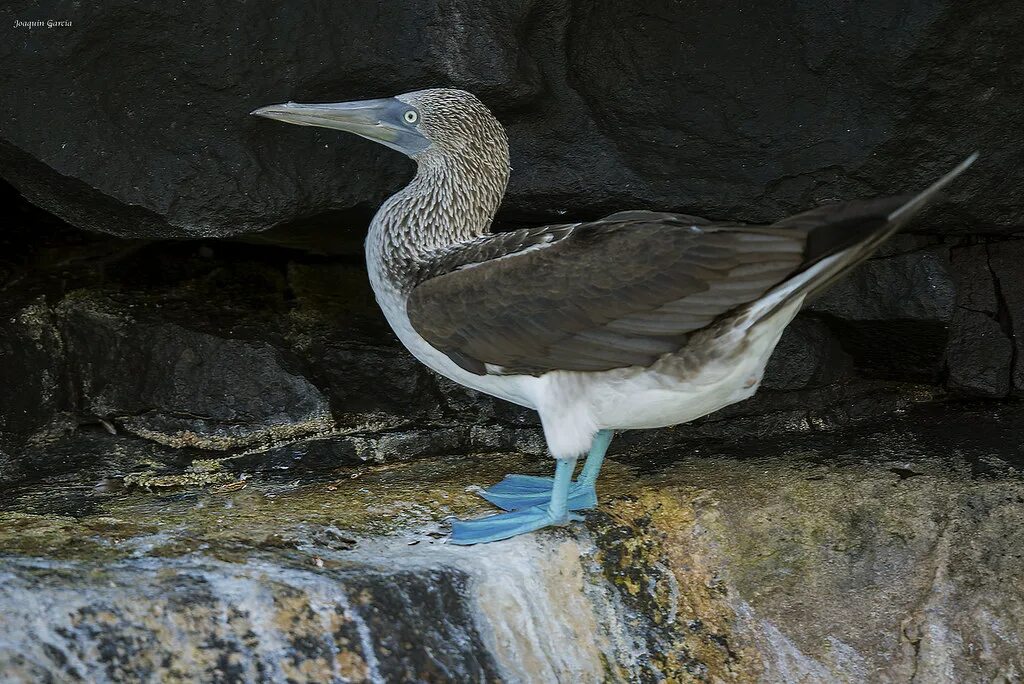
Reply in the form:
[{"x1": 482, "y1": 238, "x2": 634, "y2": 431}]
[{"x1": 0, "y1": 0, "x2": 1011, "y2": 240}]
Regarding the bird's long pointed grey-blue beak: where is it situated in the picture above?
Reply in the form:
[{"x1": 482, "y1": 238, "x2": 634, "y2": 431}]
[{"x1": 250, "y1": 97, "x2": 429, "y2": 157}]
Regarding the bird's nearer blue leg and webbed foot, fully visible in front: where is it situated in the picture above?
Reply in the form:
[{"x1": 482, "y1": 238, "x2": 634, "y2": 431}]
[{"x1": 450, "y1": 458, "x2": 583, "y2": 545}]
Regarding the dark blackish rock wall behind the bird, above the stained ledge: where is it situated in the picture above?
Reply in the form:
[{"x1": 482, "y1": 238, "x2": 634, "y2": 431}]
[{"x1": 0, "y1": 0, "x2": 1024, "y2": 478}]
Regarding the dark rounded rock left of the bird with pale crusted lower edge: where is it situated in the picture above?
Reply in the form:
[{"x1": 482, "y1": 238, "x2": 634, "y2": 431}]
[{"x1": 57, "y1": 296, "x2": 334, "y2": 450}]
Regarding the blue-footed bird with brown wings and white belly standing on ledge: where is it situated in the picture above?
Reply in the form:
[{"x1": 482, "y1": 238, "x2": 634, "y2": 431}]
[{"x1": 251, "y1": 88, "x2": 978, "y2": 545}]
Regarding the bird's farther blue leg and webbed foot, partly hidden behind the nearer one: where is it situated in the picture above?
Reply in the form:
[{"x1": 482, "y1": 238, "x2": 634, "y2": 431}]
[{"x1": 480, "y1": 430, "x2": 614, "y2": 511}]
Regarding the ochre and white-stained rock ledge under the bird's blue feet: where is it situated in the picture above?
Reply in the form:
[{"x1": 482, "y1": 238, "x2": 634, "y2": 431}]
[{"x1": 0, "y1": 404, "x2": 1024, "y2": 682}]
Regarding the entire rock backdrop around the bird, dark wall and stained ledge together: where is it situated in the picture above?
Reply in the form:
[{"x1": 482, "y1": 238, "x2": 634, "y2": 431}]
[{"x1": 0, "y1": 5, "x2": 1024, "y2": 682}]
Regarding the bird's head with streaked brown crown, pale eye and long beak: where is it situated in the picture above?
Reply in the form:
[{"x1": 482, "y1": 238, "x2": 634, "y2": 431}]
[{"x1": 252, "y1": 88, "x2": 508, "y2": 163}]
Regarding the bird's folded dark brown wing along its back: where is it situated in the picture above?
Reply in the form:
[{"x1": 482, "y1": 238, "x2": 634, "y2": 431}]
[{"x1": 408, "y1": 198, "x2": 921, "y2": 375}]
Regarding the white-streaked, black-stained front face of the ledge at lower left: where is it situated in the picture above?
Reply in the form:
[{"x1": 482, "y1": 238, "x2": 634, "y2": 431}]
[{"x1": 0, "y1": 562, "x2": 497, "y2": 682}]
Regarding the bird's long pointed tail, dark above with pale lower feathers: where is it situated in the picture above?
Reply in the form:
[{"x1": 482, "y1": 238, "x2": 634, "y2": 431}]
[{"x1": 753, "y1": 153, "x2": 978, "y2": 319}]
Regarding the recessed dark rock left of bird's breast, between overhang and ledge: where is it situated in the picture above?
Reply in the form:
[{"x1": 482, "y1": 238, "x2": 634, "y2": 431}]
[{"x1": 0, "y1": 222, "x2": 561, "y2": 483}]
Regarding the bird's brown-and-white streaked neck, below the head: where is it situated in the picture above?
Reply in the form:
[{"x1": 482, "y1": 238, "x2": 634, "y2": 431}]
[{"x1": 367, "y1": 149, "x2": 509, "y2": 280}]
